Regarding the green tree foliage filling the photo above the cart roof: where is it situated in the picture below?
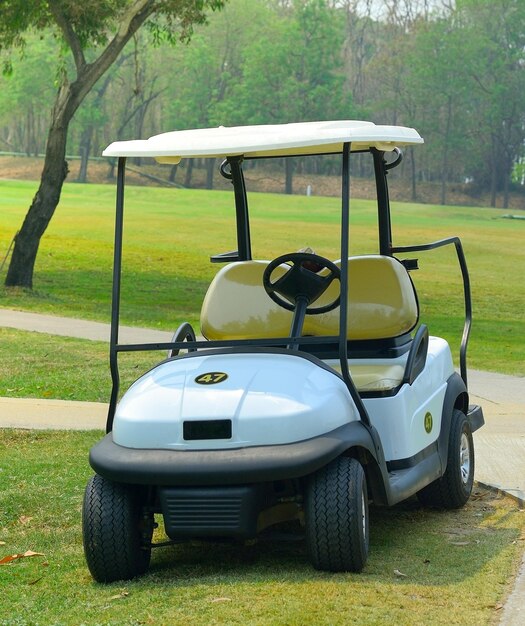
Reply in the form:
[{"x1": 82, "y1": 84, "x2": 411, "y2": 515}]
[{"x1": 0, "y1": 0, "x2": 525, "y2": 286}]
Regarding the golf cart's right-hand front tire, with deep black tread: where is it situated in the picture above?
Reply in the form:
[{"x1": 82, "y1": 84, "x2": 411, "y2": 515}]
[{"x1": 305, "y1": 457, "x2": 369, "y2": 572}]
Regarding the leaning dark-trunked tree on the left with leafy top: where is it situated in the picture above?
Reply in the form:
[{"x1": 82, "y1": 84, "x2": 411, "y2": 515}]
[{"x1": 0, "y1": 0, "x2": 223, "y2": 288}]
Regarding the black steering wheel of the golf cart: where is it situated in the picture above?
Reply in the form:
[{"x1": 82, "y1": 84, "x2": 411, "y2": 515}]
[{"x1": 263, "y1": 252, "x2": 341, "y2": 315}]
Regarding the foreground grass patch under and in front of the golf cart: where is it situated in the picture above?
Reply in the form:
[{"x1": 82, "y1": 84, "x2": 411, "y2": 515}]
[{"x1": 0, "y1": 430, "x2": 525, "y2": 626}]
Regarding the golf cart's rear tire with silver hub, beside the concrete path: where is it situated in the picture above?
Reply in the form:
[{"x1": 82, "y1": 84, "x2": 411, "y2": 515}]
[{"x1": 417, "y1": 409, "x2": 474, "y2": 509}]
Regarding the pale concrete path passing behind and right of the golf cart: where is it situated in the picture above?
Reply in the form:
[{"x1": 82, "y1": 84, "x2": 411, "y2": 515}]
[{"x1": 0, "y1": 309, "x2": 525, "y2": 626}]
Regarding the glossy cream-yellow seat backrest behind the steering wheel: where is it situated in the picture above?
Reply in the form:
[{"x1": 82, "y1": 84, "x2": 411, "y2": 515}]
[{"x1": 201, "y1": 255, "x2": 418, "y2": 340}]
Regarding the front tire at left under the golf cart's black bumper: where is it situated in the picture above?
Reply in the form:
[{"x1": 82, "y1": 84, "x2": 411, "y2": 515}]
[{"x1": 82, "y1": 475, "x2": 153, "y2": 583}]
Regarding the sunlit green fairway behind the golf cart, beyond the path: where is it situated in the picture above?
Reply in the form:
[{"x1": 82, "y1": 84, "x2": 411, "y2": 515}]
[{"x1": 0, "y1": 181, "x2": 525, "y2": 375}]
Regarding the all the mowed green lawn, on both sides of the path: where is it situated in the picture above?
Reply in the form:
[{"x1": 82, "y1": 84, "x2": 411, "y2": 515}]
[{"x1": 0, "y1": 181, "x2": 525, "y2": 626}]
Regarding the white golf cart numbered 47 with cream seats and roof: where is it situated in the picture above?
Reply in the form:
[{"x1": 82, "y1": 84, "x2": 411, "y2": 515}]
[{"x1": 83, "y1": 121, "x2": 484, "y2": 582}]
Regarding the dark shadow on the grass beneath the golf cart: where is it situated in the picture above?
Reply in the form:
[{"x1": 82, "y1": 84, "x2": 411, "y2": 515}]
[{"x1": 141, "y1": 491, "x2": 520, "y2": 586}]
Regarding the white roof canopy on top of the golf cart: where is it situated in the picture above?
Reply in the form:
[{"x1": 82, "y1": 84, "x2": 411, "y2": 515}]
[{"x1": 103, "y1": 120, "x2": 423, "y2": 163}]
